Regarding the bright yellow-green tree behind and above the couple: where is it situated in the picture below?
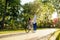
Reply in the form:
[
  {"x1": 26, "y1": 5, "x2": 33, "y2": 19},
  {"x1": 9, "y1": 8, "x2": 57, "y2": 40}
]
[{"x1": 23, "y1": 0, "x2": 54, "y2": 25}]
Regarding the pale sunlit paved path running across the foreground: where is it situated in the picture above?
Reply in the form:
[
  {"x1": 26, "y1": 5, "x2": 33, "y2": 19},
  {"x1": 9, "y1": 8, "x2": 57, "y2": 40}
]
[{"x1": 0, "y1": 29, "x2": 57, "y2": 40}]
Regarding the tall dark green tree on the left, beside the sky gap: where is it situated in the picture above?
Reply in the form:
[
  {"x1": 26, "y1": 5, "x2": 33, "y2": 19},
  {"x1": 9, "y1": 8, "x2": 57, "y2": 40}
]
[{"x1": 0, "y1": 0, "x2": 20, "y2": 29}]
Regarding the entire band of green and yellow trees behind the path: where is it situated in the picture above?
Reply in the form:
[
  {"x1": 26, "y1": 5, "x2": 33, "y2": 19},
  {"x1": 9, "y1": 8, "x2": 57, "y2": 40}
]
[{"x1": 0, "y1": 0, "x2": 60, "y2": 30}]
